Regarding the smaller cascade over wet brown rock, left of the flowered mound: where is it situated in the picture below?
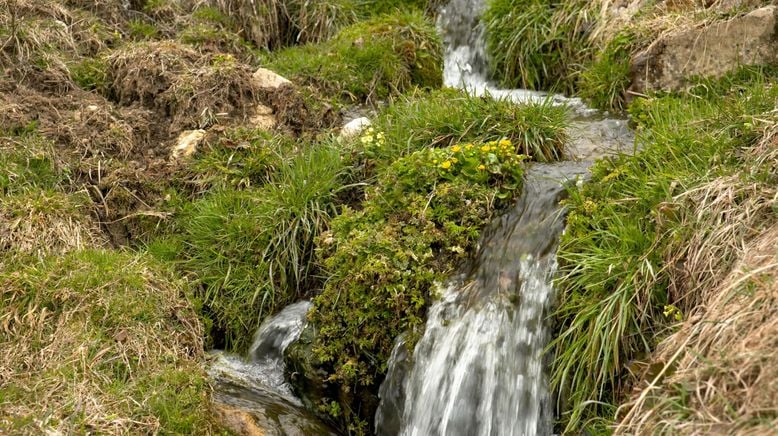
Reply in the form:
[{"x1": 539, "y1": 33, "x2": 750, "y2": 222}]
[{"x1": 209, "y1": 301, "x2": 333, "y2": 436}]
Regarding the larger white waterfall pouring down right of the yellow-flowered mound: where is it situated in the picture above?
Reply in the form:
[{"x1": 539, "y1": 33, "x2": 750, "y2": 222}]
[{"x1": 376, "y1": 163, "x2": 587, "y2": 436}]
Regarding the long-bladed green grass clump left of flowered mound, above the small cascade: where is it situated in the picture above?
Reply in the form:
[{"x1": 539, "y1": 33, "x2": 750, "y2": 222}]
[{"x1": 177, "y1": 142, "x2": 343, "y2": 351}]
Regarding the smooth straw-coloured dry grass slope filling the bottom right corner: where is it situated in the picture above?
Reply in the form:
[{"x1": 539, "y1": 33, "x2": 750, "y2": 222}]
[{"x1": 616, "y1": 226, "x2": 778, "y2": 435}]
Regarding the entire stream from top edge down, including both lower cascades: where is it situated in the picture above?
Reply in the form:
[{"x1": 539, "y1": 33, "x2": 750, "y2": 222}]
[{"x1": 210, "y1": 0, "x2": 634, "y2": 436}]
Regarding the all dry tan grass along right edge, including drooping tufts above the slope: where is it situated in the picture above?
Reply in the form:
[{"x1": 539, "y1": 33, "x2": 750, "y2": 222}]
[{"x1": 616, "y1": 129, "x2": 778, "y2": 435}]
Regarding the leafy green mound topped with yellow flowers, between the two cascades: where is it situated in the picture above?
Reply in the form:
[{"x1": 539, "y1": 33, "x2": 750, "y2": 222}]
[{"x1": 310, "y1": 140, "x2": 522, "y2": 432}]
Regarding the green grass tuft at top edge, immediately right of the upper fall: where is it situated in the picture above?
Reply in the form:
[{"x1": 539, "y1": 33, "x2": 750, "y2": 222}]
[{"x1": 483, "y1": 0, "x2": 589, "y2": 91}]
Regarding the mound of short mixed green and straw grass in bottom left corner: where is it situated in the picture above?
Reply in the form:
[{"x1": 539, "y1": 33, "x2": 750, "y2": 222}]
[{"x1": 0, "y1": 251, "x2": 215, "y2": 434}]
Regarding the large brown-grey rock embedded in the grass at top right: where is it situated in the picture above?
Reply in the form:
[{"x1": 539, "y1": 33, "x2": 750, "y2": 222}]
[{"x1": 630, "y1": 5, "x2": 778, "y2": 93}]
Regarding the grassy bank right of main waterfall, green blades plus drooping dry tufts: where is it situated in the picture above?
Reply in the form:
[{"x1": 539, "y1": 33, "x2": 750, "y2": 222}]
[{"x1": 553, "y1": 69, "x2": 778, "y2": 431}]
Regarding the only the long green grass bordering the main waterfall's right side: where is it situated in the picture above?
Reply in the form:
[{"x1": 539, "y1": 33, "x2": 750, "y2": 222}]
[{"x1": 551, "y1": 69, "x2": 778, "y2": 431}]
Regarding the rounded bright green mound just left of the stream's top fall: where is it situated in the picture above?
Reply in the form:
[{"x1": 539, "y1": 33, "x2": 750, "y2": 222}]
[{"x1": 268, "y1": 13, "x2": 442, "y2": 102}]
